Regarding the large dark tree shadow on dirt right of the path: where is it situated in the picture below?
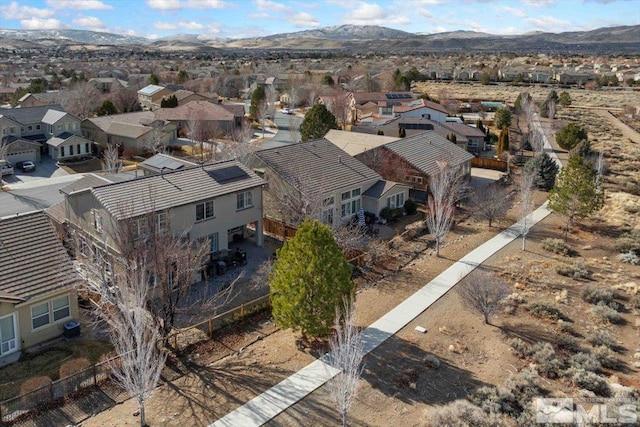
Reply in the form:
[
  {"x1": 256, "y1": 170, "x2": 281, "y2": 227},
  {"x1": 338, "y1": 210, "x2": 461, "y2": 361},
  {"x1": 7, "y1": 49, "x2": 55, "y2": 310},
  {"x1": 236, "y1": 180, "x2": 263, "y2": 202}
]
[{"x1": 362, "y1": 335, "x2": 488, "y2": 405}]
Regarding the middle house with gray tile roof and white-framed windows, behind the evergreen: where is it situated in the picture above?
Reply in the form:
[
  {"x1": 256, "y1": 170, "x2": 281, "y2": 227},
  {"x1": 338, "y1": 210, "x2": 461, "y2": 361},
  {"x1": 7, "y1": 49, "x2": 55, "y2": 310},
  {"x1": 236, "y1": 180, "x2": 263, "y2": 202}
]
[{"x1": 249, "y1": 139, "x2": 409, "y2": 226}]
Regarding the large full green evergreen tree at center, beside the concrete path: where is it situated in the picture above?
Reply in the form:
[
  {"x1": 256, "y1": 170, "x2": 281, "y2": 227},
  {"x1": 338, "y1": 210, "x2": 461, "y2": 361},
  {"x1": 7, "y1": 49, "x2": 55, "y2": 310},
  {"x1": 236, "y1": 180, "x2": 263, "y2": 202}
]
[{"x1": 269, "y1": 218, "x2": 355, "y2": 338}]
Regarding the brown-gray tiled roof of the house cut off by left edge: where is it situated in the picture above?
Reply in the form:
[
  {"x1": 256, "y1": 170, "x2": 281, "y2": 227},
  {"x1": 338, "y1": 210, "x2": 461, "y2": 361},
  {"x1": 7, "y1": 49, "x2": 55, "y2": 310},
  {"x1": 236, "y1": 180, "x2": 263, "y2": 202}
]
[{"x1": 0, "y1": 211, "x2": 77, "y2": 301}]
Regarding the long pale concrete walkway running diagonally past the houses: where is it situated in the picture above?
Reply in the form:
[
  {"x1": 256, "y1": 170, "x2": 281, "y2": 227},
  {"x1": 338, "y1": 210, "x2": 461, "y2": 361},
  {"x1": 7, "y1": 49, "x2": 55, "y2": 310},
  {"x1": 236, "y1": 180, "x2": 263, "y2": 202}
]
[{"x1": 209, "y1": 116, "x2": 560, "y2": 427}]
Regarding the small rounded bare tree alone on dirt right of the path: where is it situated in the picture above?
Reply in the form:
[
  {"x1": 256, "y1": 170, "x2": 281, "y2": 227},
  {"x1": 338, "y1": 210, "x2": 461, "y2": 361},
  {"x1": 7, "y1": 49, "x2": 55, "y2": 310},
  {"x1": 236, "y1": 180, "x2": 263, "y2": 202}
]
[{"x1": 456, "y1": 270, "x2": 509, "y2": 325}]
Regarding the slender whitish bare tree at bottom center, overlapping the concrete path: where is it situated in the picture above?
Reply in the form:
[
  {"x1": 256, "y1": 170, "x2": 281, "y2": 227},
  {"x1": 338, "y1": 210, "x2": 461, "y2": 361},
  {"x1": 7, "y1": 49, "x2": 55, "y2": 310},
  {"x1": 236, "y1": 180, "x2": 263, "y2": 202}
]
[{"x1": 327, "y1": 297, "x2": 364, "y2": 427}]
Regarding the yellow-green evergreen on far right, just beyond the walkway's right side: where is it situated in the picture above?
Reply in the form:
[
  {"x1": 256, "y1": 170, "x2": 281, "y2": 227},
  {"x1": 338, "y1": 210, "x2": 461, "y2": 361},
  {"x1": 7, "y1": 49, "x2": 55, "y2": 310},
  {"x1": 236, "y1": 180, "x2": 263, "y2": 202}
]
[{"x1": 549, "y1": 156, "x2": 604, "y2": 241}]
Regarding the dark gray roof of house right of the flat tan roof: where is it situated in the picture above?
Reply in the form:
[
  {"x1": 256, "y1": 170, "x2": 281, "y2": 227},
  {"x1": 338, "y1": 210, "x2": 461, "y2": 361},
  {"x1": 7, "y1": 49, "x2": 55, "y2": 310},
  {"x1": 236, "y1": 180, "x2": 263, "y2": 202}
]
[{"x1": 385, "y1": 131, "x2": 473, "y2": 175}]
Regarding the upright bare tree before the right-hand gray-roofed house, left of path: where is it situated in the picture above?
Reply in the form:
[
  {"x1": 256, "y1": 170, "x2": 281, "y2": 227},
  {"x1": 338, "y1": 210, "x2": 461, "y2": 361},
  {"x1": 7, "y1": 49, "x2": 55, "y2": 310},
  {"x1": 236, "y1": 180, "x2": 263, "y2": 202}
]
[{"x1": 425, "y1": 161, "x2": 464, "y2": 256}]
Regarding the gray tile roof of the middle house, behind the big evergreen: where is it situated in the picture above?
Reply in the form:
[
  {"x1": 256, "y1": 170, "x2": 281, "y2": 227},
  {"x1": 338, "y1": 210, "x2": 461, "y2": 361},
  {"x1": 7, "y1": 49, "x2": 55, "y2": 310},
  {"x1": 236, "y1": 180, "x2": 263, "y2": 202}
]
[{"x1": 254, "y1": 138, "x2": 380, "y2": 193}]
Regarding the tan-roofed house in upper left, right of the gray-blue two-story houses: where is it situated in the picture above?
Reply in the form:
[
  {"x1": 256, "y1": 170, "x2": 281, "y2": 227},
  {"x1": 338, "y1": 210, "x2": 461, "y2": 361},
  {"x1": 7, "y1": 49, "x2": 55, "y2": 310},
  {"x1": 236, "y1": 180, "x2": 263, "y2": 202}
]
[{"x1": 81, "y1": 111, "x2": 177, "y2": 153}]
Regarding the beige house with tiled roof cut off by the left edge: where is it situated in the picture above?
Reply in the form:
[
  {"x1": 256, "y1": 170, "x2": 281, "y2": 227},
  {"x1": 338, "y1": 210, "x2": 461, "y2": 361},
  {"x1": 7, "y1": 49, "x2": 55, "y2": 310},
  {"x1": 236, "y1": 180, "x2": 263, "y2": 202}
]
[{"x1": 0, "y1": 211, "x2": 78, "y2": 366}]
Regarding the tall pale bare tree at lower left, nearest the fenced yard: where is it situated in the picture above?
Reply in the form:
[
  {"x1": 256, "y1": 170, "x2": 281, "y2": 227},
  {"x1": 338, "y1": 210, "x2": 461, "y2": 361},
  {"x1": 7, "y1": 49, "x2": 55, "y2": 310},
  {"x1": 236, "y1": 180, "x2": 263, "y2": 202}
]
[{"x1": 83, "y1": 250, "x2": 166, "y2": 427}]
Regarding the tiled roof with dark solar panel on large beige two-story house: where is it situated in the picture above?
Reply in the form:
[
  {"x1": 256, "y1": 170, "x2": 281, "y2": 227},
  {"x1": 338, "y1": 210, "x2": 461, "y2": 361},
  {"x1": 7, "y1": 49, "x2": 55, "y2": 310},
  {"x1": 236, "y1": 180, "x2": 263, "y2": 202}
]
[{"x1": 91, "y1": 160, "x2": 265, "y2": 220}]
